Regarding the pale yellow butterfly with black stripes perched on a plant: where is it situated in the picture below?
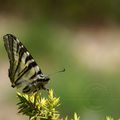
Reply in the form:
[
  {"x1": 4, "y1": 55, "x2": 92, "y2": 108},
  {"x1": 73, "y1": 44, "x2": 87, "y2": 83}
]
[{"x1": 3, "y1": 34, "x2": 50, "y2": 94}]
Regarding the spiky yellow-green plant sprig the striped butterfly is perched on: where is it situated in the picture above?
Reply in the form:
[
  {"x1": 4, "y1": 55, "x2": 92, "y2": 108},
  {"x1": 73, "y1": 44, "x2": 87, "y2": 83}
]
[{"x1": 17, "y1": 90, "x2": 80, "y2": 120}]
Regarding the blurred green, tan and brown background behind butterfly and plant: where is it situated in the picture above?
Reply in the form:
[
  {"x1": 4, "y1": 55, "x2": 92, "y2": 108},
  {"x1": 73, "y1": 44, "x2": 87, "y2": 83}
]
[{"x1": 0, "y1": 0, "x2": 120, "y2": 120}]
